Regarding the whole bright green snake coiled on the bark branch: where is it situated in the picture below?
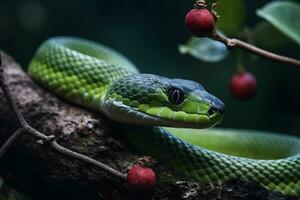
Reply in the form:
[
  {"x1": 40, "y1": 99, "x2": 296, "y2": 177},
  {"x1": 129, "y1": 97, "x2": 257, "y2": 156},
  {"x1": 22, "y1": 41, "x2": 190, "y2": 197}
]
[{"x1": 28, "y1": 37, "x2": 300, "y2": 196}]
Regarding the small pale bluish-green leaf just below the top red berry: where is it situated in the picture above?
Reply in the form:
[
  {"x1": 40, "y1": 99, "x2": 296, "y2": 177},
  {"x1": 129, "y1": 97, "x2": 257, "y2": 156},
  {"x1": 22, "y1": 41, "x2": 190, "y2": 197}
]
[{"x1": 179, "y1": 37, "x2": 228, "y2": 62}]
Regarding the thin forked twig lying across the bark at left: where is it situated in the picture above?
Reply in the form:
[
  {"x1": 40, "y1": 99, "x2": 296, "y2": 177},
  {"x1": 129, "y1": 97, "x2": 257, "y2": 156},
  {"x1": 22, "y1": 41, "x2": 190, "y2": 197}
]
[{"x1": 0, "y1": 53, "x2": 126, "y2": 179}]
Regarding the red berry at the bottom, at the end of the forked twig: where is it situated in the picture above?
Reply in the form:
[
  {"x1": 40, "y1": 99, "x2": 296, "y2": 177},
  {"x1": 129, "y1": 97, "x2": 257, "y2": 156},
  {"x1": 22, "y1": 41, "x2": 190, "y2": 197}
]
[{"x1": 127, "y1": 165, "x2": 156, "y2": 195}]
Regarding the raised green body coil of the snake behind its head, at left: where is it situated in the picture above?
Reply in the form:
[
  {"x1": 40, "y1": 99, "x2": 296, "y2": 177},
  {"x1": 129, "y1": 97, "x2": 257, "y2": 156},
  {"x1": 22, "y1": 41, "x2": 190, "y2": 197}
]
[{"x1": 28, "y1": 37, "x2": 138, "y2": 115}]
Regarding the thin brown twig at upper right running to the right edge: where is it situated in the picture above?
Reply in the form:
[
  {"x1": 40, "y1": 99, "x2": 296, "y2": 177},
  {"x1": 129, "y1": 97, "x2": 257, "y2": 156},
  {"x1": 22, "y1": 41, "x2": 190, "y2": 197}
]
[{"x1": 211, "y1": 33, "x2": 300, "y2": 67}]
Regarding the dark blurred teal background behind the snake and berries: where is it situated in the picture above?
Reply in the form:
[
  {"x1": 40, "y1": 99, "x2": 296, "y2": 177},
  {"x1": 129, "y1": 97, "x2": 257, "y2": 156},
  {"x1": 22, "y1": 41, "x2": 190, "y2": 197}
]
[{"x1": 0, "y1": 0, "x2": 300, "y2": 134}]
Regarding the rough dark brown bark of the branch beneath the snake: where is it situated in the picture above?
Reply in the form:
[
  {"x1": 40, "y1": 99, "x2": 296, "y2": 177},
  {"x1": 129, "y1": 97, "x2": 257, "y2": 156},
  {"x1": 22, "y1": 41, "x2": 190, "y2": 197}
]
[{"x1": 0, "y1": 52, "x2": 296, "y2": 200}]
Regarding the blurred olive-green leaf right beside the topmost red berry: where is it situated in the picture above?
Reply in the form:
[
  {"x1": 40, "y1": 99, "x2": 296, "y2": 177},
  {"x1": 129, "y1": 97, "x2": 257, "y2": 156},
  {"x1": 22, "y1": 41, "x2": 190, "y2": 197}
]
[{"x1": 216, "y1": 0, "x2": 246, "y2": 36}]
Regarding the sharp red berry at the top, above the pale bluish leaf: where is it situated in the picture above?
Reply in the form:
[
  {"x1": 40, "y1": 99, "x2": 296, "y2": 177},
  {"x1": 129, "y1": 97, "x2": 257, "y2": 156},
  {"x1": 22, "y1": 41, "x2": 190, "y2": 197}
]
[{"x1": 185, "y1": 8, "x2": 215, "y2": 37}]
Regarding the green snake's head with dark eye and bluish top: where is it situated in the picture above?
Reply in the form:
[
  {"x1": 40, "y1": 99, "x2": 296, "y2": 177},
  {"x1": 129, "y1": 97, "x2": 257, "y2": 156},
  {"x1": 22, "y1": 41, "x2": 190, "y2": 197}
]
[{"x1": 103, "y1": 74, "x2": 225, "y2": 128}]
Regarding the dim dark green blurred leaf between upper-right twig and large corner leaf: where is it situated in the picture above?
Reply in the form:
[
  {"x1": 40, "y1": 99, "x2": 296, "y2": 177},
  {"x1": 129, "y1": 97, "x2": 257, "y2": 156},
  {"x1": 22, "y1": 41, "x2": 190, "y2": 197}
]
[{"x1": 253, "y1": 21, "x2": 291, "y2": 49}]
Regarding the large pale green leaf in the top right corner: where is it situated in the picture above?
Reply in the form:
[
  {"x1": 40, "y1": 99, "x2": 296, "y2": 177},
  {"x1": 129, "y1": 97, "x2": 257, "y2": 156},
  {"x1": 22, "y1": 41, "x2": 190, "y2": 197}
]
[{"x1": 256, "y1": 1, "x2": 300, "y2": 45}]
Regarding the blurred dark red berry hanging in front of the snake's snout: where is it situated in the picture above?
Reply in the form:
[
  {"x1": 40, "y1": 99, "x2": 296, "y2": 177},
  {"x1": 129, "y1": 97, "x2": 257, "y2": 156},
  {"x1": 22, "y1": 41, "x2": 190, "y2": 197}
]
[{"x1": 230, "y1": 72, "x2": 257, "y2": 100}]
